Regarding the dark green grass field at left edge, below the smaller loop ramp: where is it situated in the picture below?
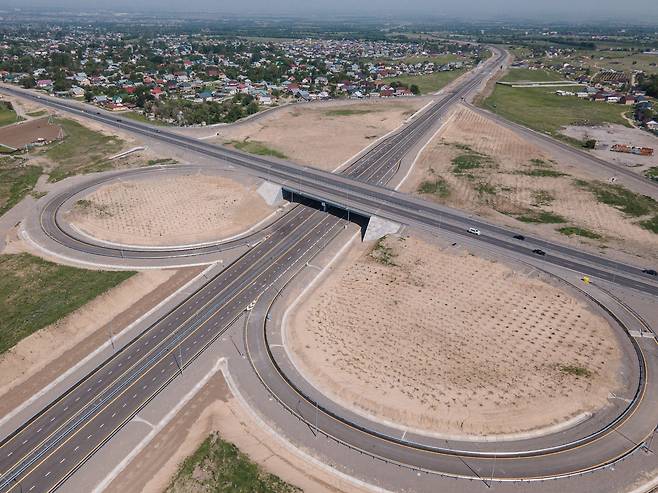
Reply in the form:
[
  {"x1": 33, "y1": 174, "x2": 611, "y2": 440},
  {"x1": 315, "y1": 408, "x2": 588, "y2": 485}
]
[{"x1": 0, "y1": 253, "x2": 134, "y2": 354}]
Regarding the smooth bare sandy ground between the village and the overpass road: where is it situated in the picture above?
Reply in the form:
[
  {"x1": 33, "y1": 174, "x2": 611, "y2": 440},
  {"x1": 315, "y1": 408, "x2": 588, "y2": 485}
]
[{"x1": 211, "y1": 98, "x2": 429, "y2": 170}]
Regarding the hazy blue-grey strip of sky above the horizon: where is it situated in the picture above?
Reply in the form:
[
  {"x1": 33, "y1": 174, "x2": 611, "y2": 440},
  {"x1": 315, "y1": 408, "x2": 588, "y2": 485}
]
[{"x1": 0, "y1": 0, "x2": 658, "y2": 23}]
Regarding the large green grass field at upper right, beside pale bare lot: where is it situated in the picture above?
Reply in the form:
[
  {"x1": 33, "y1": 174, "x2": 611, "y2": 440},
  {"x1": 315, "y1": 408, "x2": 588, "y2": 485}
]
[{"x1": 483, "y1": 84, "x2": 630, "y2": 135}]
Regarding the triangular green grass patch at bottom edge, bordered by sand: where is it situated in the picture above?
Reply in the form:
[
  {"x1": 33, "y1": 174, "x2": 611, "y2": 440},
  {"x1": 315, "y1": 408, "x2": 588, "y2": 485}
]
[{"x1": 166, "y1": 433, "x2": 302, "y2": 493}]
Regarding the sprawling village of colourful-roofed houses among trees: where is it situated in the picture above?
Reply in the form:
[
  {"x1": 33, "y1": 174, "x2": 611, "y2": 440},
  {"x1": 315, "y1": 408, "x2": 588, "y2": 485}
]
[{"x1": 0, "y1": 28, "x2": 474, "y2": 125}]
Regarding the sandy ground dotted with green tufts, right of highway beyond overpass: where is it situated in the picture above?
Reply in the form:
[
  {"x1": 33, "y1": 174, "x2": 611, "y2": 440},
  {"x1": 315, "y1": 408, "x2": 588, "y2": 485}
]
[{"x1": 402, "y1": 107, "x2": 658, "y2": 259}]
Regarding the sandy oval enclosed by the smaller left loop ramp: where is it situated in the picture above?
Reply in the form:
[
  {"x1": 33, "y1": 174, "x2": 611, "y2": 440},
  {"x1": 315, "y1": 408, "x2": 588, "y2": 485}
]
[{"x1": 69, "y1": 175, "x2": 273, "y2": 245}]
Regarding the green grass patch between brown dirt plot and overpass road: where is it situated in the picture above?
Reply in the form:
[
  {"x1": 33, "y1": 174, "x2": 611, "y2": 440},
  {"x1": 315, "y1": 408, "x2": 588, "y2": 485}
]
[{"x1": 43, "y1": 119, "x2": 124, "y2": 181}]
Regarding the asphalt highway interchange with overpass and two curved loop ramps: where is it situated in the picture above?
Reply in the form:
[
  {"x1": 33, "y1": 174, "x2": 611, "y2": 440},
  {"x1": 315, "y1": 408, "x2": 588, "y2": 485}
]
[{"x1": 0, "y1": 45, "x2": 658, "y2": 491}]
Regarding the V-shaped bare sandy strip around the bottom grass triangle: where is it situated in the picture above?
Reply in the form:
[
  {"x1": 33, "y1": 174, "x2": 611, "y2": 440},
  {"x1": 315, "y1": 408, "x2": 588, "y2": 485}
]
[{"x1": 106, "y1": 375, "x2": 372, "y2": 493}]
